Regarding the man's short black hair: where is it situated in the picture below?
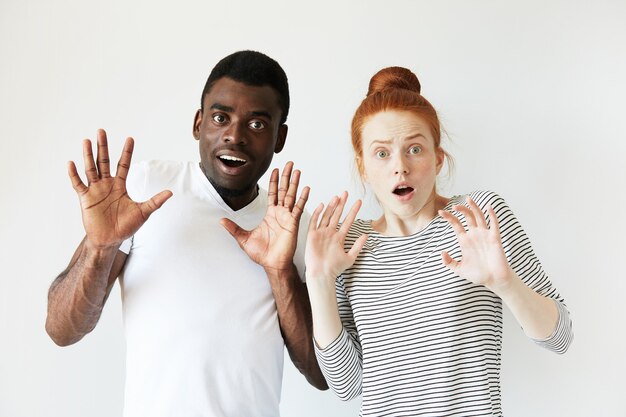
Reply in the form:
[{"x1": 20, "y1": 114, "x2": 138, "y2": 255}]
[{"x1": 200, "y1": 50, "x2": 289, "y2": 124}]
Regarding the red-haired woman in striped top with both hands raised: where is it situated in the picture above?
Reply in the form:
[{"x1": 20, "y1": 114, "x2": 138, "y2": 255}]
[{"x1": 305, "y1": 67, "x2": 572, "y2": 416}]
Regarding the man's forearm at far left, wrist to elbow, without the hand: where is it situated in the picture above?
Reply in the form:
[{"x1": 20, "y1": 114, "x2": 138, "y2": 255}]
[{"x1": 46, "y1": 239, "x2": 118, "y2": 346}]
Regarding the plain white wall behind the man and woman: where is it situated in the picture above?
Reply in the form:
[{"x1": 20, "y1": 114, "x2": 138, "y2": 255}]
[{"x1": 0, "y1": 0, "x2": 626, "y2": 417}]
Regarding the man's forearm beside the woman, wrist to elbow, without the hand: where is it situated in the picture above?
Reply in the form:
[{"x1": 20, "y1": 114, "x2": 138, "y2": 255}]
[{"x1": 265, "y1": 264, "x2": 328, "y2": 390}]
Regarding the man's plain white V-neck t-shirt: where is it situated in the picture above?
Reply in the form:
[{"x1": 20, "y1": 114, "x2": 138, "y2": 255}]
[{"x1": 120, "y1": 161, "x2": 308, "y2": 417}]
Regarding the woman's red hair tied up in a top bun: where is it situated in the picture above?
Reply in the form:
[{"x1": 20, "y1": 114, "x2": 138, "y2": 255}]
[{"x1": 352, "y1": 67, "x2": 448, "y2": 176}]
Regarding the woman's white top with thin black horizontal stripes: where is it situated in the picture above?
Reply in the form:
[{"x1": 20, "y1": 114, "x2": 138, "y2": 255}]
[{"x1": 316, "y1": 192, "x2": 572, "y2": 416}]
